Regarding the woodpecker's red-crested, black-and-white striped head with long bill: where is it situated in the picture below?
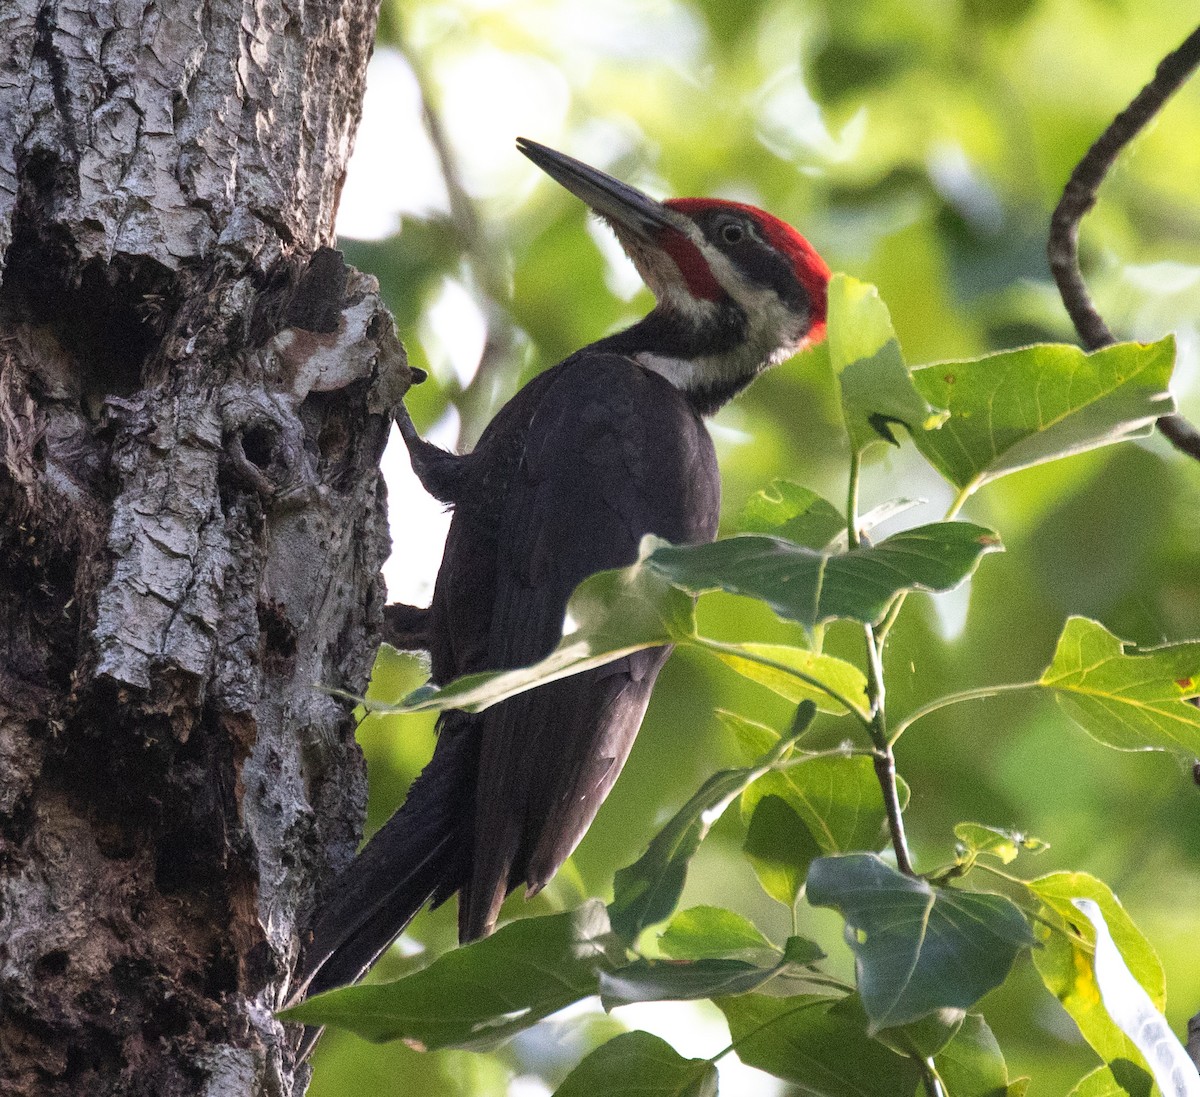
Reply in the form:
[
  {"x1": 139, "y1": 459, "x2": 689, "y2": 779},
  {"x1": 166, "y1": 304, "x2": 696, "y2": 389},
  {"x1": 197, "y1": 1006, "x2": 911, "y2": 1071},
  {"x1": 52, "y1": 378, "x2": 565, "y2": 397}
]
[{"x1": 517, "y1": 138, "x2": 829, "y2": 414}]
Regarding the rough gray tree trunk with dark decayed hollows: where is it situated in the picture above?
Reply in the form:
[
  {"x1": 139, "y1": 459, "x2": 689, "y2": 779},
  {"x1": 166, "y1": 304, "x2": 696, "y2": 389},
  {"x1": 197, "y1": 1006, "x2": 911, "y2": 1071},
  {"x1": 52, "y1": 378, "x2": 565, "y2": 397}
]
[{"x1": 0, "y1": 0, "x2": 409, "y2": 1097}]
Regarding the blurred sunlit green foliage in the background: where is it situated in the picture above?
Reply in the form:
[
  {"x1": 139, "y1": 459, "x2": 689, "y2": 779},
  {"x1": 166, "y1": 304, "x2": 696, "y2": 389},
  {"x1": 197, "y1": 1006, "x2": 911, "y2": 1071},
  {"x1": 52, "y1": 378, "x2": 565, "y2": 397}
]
[{"x1": 319, "y1": 0, "x2": 1200, "y2": 1097}]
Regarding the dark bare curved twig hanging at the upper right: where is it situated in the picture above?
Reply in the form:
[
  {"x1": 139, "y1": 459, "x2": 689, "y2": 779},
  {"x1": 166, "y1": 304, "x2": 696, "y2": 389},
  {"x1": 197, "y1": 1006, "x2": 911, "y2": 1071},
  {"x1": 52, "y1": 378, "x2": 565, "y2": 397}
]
[{"x1": 1046, "y1": 28, "x2": 1200, "y2": 461}]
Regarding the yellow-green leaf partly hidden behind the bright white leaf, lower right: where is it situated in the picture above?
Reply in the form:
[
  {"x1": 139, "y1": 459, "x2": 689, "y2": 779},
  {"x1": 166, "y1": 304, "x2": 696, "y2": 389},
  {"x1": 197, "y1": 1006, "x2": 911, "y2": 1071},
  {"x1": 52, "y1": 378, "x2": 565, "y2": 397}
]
[{"x1": 1026, "y1": 873, "x2": 1166, "y2": 1063}]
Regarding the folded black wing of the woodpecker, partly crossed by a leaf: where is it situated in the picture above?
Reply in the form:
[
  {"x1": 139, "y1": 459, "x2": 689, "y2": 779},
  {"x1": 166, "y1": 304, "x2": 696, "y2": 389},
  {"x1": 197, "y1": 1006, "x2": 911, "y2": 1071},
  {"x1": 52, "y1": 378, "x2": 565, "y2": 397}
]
[{"x1": 439, "y1": 352, "x2": 720, "y2": 940}]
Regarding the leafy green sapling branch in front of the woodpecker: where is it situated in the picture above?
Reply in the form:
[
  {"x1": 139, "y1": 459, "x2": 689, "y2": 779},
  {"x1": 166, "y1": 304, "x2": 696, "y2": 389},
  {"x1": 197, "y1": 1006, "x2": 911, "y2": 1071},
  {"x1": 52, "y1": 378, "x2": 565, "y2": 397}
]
[{"x1": 312, "y1": 267, "x2": 1200, "y2": 1097}]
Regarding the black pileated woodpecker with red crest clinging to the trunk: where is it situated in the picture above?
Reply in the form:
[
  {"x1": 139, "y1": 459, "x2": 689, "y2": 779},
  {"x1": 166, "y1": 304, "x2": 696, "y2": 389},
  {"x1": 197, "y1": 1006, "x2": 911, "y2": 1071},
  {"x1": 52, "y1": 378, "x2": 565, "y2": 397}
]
[{"x1": 296, "y1": 139, "x2": 829, "y2": 996}]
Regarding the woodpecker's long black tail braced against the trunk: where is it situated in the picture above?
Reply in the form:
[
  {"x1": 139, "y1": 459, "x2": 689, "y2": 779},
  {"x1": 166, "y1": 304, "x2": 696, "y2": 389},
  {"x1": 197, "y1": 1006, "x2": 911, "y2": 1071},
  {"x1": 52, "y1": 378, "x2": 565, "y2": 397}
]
[{"x1": 288, "y1": 713, "x2": 478, "y2": 1055}]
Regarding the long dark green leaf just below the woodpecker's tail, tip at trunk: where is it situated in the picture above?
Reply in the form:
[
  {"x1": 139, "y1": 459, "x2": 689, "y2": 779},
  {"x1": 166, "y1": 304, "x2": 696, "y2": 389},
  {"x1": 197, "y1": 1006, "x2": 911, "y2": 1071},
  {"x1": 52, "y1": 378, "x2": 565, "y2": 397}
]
[{"x1": 280, "y1": 900, "x2": 625, "y2": 1050}]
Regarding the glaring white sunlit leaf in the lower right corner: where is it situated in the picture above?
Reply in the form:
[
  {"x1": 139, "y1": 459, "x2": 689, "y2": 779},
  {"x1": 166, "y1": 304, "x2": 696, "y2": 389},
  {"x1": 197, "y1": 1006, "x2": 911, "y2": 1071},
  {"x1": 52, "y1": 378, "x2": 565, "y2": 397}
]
[{"x1": 1073, "y1": 899, "x2": 1200, "y2": 1097}]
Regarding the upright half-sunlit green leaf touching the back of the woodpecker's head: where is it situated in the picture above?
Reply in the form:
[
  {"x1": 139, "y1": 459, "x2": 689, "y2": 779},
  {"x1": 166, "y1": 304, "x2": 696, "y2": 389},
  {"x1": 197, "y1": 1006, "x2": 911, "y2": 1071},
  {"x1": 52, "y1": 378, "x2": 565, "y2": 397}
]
[{"x1": 828, "y1": 275, "x2": 946, "y2": 450}]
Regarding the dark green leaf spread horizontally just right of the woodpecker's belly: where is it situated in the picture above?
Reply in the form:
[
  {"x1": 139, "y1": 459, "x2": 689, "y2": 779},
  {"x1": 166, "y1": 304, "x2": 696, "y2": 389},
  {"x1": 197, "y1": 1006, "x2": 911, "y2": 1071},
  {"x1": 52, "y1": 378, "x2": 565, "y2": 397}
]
[{"x1": 647, "y1": 522, "x2": 1002, "y2": 628}]
